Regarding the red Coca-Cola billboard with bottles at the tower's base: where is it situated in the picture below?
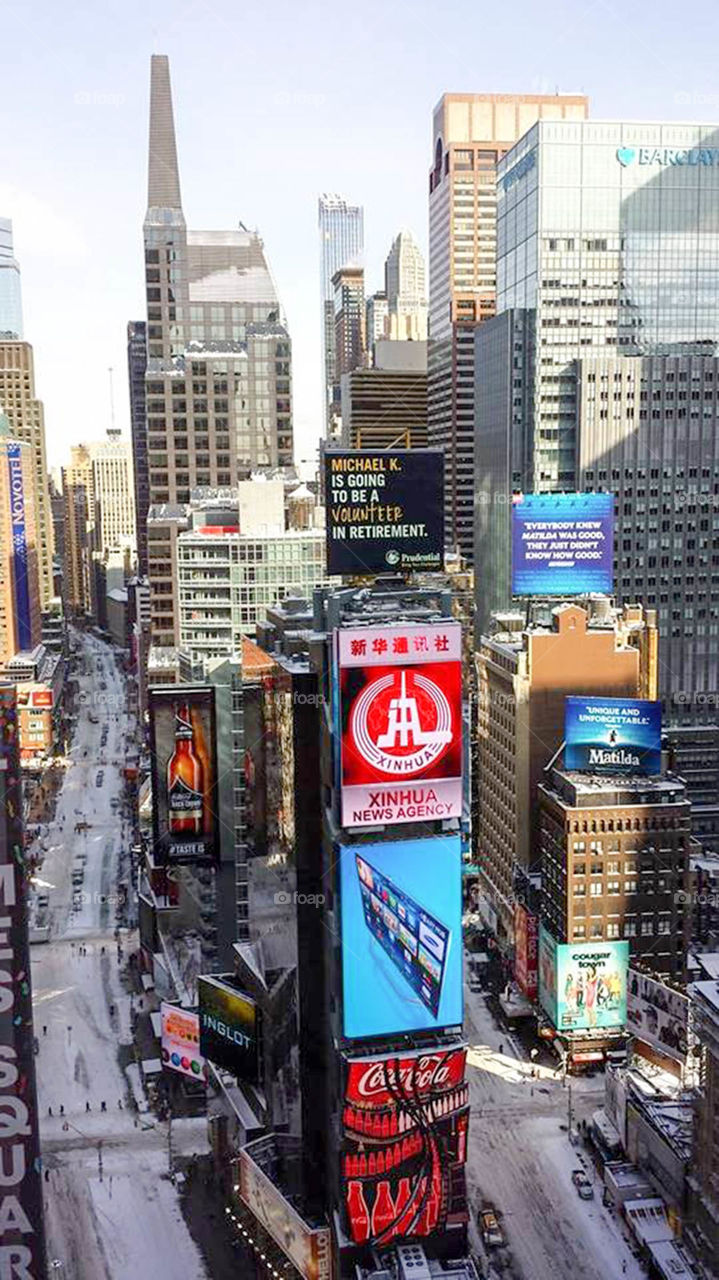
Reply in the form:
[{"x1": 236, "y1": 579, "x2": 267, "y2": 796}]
[{"x1": 340, "y1": 1047, "x2": 470, "y2": 1245}]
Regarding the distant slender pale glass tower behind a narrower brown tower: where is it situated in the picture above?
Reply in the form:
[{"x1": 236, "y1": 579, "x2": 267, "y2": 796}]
[{"x1": 317, "y1": 193, "x2": 365, "y2": 435}]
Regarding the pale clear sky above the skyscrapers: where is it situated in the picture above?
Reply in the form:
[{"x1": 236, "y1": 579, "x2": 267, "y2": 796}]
[{"x1": 0, "y1": 0, "x2": 719, "y2": 465}]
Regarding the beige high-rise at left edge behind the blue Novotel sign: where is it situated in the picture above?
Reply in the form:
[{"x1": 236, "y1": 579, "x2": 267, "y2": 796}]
[{"x1": 0, "y1": 337, "x2": 55, "y2": 609}]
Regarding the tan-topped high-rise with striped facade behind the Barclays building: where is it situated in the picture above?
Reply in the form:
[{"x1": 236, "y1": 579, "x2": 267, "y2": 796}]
[{"x1": 429, "y1": 93, "x2": 589, "y2": 562}]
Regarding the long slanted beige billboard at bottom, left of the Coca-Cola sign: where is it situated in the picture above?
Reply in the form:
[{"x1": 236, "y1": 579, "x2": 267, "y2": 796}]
[{"x1": 239, "y1": 1138, "x2": 333, "y2": 1280}]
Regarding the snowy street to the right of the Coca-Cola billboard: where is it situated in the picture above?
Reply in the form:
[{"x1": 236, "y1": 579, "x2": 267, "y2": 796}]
[{"x1": 464, "y1": 967, "x2": 645, "y2": 1280}]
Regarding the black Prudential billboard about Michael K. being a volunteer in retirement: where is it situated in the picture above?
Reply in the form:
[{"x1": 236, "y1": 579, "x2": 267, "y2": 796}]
[{"x1": 325, "y1": 449, "x2": 444, "y2": 575}]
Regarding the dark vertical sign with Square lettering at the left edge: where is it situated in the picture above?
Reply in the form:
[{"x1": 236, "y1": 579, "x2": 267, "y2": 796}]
[{"x1": 0, "y1": 685, "x2": 46, "y2": 1280}]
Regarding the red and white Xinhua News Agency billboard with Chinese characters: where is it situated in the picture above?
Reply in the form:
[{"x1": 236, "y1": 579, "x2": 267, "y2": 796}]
[{"x1": 335, "y1": 621, "x2": 462, "y2": 827}]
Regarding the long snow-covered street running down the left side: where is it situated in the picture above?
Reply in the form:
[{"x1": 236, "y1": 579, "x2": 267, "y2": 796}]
[{"x1": 32, "y1": 635, "x2": 207, "y2": 1280}]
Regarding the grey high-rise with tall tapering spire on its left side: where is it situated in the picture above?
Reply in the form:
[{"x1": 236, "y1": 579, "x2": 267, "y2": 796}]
[{"x1": 143, "y1": 56, "x2": 293, "y2": 644}]
